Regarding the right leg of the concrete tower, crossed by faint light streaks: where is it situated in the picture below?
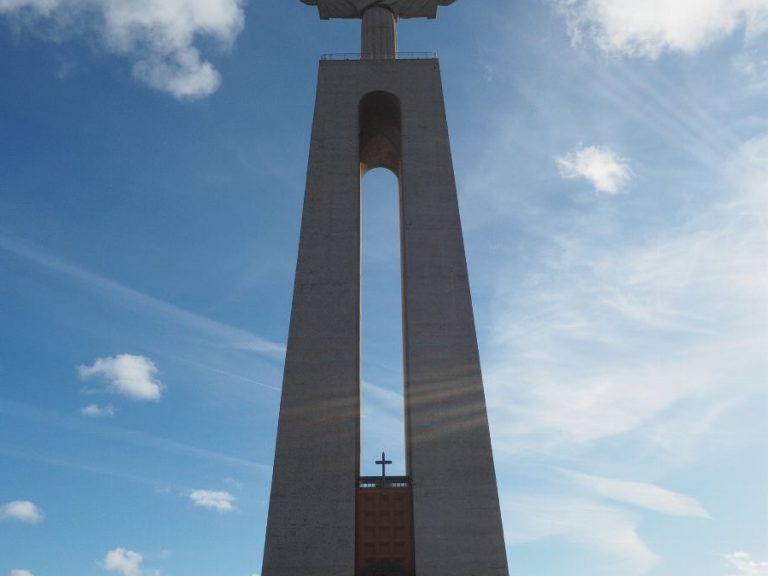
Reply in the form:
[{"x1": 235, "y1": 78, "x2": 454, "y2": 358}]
[{"x1": 399, "y1": 60, "x2": 508, "y2": 576}]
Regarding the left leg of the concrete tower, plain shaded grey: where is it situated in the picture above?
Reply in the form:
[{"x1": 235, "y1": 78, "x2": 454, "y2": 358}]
[{"x1": 262, "y1": 67, "x2": 360, "y2": 576}]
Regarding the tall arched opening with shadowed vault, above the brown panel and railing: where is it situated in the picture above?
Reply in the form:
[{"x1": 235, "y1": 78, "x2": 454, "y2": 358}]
[{"x1": 359, "y1": 92, "x2": 407, "y2": 476}]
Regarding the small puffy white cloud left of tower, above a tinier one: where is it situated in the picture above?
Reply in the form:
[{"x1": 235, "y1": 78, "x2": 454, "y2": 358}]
[{"x1": 77, "y1": 354, "x2": 162, "y2": 401}]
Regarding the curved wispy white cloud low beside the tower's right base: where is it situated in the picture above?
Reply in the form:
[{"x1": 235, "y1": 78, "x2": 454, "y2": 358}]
[{"x1": 502, "y1": 495, "x2": 659, "y2": 574}]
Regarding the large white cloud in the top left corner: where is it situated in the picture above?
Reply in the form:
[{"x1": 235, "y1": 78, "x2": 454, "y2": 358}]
[{"x1": 0, "y1": 0, "x2": 245, "y2": 99}]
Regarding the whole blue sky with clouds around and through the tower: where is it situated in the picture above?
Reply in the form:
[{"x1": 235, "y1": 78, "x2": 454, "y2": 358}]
[{"x1": 0, "y1": 0, "x2": 768, "y2": 576}]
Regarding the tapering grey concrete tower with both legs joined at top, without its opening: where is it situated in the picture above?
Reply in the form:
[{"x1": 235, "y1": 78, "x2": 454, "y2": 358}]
[{"x1": 262, "y1": 60, "x2": 508, "y2": 576}]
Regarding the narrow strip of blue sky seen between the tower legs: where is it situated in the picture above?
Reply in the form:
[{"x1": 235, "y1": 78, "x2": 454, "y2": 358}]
[{"x1": 360, "y1": 168, "x2": 406, "y2": 476}]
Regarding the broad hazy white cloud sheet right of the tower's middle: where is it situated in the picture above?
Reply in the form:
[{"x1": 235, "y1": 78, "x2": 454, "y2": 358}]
[{"x1": 487, "y1": 133, "x2": 768, "y2": 451}]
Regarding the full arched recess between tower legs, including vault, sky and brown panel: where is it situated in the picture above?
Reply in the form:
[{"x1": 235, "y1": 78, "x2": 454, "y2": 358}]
[{"x1": 355, "y1": 92, "x2": 415, "y2": 576}]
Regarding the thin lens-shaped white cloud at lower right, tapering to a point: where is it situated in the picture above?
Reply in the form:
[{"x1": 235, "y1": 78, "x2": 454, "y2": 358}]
[{"x1": 568, "y1": 472, "x2": 710, "y2": 518}]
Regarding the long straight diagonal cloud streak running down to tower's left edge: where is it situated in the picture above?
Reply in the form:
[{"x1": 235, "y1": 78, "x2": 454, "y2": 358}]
[{"x1": 0, "y1": 231, "x2": 285, "y2": 360}]
